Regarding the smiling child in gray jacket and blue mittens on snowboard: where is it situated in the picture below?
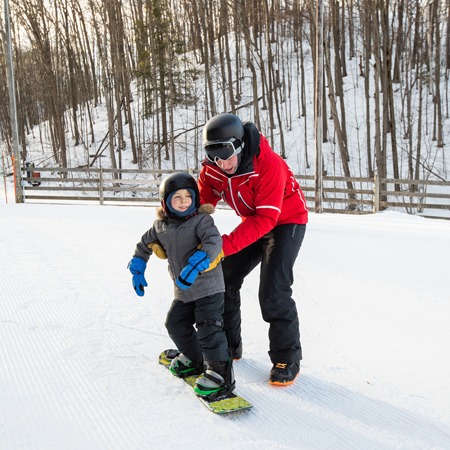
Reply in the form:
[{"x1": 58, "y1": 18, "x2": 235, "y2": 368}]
[{"x1": 129, "y1": 172, "x2": 235, "y2": 400}]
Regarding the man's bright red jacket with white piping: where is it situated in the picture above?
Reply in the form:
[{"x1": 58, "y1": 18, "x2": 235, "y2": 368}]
[{"x1": 198, "y1": 135, "x2": 308, "y2": 256}]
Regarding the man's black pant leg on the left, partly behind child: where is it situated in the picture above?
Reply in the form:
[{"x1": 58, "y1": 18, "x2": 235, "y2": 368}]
[{"x1": 222, "y1": 240, "x2": 262, "y2": 350}]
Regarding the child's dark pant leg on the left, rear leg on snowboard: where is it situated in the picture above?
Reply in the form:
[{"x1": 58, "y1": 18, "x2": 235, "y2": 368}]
[{"x1": 165, "y1": 300, "x2": 203, "y2": 363}]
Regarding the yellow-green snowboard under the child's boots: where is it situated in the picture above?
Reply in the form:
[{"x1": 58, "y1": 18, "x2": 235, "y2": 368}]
[{"x1": 159, "y1": 349, "x2": 253, "y2": 414}]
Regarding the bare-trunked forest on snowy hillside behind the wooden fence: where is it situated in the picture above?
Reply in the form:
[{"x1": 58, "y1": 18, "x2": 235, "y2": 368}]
[{"x1": 0, "y1": 0, "x2": 450, "y2": 180}]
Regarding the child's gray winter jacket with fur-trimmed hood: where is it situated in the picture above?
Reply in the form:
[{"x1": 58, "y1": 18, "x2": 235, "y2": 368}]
[{"x1": 133, "y1": 204, "x2": 225, "y2": 302}]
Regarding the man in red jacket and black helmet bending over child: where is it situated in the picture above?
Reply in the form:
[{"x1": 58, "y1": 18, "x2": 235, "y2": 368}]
[{"x1": 199, "y1": 113, "x2": 308, "y2": 385}]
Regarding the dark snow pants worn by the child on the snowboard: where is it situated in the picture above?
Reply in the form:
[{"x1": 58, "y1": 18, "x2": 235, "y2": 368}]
[{"x1": 165, "y1": 293, "x2": 230, "y2": 363}]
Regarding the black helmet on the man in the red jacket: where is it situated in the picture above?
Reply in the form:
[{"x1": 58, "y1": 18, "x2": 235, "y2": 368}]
[{"x1": 203, "y1": 113, "x2": 245, "y2": 147}]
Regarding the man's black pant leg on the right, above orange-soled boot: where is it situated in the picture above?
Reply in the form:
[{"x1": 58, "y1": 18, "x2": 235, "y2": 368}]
[{"x1": 259, "y1": 224, "x2": 306, "y2": 363}]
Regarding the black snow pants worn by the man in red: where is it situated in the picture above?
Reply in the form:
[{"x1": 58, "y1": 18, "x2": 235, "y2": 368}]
[{"x1": 222, "y1": 223, "x2": 306, "y2": 364}]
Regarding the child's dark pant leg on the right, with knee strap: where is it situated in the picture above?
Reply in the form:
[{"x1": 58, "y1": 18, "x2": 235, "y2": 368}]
[{"x1": 195, "y1": 293, "x2": 231, "y2": 361}]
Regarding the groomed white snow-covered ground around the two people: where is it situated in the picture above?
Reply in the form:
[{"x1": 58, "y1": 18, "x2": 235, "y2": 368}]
[{"x1": 0, "y1": 202, "x2": 450, "y2": 450}]
